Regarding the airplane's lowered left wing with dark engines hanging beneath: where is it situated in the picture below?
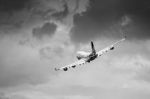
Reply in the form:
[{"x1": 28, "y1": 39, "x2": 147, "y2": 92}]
[{"x1": 55, "y1": 59, "x2": 86, "y2": 71}]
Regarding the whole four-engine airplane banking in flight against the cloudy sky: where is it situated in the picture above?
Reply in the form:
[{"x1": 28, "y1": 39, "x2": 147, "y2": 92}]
[{"x1": 55, "y1": 36, "x2": 126, "y2": 71}]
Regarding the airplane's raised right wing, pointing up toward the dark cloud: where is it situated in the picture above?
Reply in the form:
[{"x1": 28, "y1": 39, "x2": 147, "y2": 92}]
[{"x1": 97, "y1": 37, "x2": 126, "y2": 56}]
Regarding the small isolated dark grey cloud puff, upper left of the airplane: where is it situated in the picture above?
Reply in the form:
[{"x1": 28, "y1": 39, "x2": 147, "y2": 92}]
[{"x1": 32, "y1": 22, "x2": 57, "y2": 39}]
